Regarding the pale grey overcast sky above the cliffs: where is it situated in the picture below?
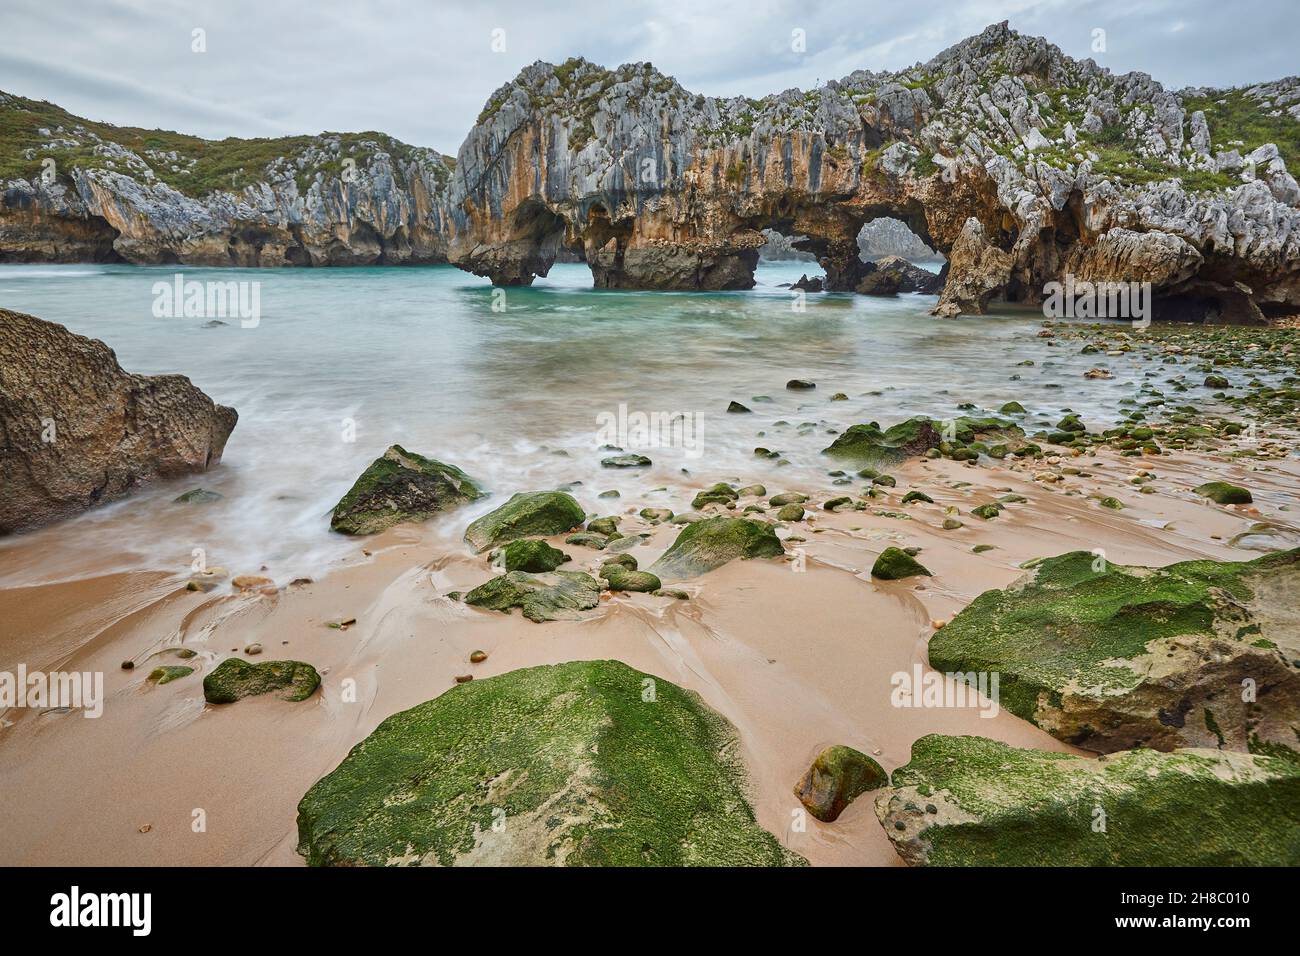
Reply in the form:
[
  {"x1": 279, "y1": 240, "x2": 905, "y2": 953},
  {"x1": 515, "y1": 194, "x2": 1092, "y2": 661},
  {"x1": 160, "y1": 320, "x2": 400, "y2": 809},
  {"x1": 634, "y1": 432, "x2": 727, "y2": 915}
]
[{"x1": 0, "y1": 0, "x2": 1300, "y2": 153}]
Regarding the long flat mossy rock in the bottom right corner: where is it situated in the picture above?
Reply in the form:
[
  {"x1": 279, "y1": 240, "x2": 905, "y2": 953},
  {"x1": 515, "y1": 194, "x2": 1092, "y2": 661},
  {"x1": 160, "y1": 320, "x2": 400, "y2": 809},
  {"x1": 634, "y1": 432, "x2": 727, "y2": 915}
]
[{"x1": 876, "y1": 733, "x2": 1300, "y2": 866}]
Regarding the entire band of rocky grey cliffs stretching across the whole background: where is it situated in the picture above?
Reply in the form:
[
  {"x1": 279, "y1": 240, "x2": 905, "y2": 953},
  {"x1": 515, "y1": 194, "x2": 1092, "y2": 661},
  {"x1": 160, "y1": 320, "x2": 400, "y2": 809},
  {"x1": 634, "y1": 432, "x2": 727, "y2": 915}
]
[{"x1": 0, "y1": 23, "x2": 1300, "y2": 324}]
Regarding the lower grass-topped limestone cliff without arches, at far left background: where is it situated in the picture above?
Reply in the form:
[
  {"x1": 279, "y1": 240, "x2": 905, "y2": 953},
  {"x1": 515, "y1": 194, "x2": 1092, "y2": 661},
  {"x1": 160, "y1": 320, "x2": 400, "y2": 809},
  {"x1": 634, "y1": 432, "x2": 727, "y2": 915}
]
[{"x1": 0, "y1": 92, "x2": 451, "y2": 265}]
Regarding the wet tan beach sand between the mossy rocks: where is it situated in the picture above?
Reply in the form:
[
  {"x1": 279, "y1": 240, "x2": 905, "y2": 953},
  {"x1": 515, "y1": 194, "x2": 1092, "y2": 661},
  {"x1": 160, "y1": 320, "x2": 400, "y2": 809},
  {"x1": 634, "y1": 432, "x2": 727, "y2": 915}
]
[{"x1": 0, "y1": 450, "x2": 1300, "y2": 865}]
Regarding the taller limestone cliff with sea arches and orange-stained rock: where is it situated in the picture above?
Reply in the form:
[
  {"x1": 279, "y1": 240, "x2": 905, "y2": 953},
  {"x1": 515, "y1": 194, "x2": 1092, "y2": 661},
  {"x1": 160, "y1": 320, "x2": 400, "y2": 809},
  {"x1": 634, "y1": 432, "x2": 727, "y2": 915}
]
[{"x1": 449, "y1": 23, "x2": 1300, "y2": 321}]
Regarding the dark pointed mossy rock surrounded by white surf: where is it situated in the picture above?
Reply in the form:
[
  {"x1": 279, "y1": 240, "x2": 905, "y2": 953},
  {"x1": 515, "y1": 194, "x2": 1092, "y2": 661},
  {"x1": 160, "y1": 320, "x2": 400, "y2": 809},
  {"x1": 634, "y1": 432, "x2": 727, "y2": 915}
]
[{"x1": 329, "y1": 445, "x2": 482, "y2": 535}]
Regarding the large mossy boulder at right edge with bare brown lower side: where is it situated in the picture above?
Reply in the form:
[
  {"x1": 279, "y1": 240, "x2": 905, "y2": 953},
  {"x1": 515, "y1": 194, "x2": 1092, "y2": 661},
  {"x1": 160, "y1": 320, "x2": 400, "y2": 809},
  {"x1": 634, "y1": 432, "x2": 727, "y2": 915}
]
[{"x1": 930, "y1": 549, "x2": 1300, "y2": 757}]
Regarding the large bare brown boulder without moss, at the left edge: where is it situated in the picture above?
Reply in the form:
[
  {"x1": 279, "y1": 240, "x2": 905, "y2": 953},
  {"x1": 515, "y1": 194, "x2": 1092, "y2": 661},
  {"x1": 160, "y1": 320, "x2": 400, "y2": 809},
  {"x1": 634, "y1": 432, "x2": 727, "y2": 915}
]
[{"x1": 0, "y1": 310, "x2": 239, "y2": 535}]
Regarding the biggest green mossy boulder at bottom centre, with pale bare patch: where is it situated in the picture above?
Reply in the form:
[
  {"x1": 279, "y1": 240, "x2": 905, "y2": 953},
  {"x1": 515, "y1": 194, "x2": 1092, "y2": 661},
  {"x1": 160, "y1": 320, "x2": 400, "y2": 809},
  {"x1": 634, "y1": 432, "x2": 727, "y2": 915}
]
[{"x1": 298, "y1": 661, "x2": 805, "y2": 866}]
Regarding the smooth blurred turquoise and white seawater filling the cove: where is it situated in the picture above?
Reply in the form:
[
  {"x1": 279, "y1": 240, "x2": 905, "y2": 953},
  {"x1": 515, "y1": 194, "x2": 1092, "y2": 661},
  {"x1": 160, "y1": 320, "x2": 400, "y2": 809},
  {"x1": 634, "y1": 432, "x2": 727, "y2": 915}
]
[{"x1": 0, "y1": 261, "x2": 1170, "y2": 583}]
